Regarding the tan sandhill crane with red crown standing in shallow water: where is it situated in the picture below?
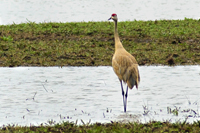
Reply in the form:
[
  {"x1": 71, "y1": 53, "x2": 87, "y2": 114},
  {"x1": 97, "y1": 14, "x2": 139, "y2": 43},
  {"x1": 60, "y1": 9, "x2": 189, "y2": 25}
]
[{"x1": 108, "y1": 14, "x2": 140, "y2": 112}]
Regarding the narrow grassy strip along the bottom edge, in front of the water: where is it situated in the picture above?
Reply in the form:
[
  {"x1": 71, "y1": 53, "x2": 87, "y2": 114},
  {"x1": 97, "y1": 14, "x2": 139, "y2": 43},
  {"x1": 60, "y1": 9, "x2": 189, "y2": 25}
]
[{"x1": 0, "y1": 121, "x2": 200, "y2": 133}]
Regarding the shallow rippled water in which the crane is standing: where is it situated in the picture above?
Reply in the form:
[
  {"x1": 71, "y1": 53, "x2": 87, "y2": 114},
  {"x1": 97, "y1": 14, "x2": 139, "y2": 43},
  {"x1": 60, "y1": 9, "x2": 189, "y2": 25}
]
[{"x1": 0, "y1": 66, "x2": 200, "y2": 126}]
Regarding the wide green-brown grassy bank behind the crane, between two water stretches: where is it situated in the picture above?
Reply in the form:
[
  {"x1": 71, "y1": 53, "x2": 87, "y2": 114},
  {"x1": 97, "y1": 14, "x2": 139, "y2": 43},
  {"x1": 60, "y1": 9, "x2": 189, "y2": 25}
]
[{"x1": 0, "y1": 19, "x2": 200, "y2": 67}]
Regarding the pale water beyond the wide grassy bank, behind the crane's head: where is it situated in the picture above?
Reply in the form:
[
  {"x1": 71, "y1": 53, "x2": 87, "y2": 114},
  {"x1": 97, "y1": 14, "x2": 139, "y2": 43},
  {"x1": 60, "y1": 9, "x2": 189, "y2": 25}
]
[{"x1": 0, "y1": 0, "x2": 200, "y2": 25}]
